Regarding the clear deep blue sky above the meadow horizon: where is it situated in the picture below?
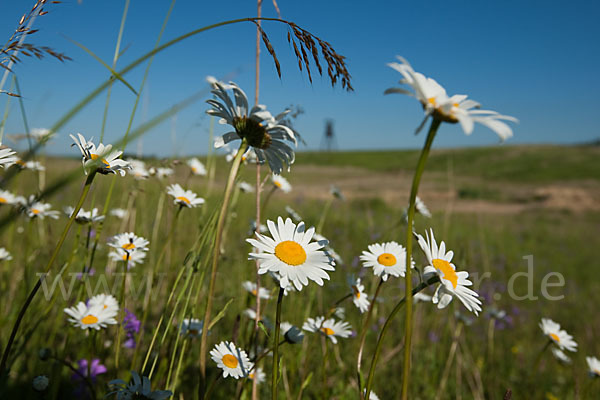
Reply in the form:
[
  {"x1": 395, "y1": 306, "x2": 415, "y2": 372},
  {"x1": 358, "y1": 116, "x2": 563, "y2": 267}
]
[{"x1": 0, "y1": 0, "x2": 600, "y2": 156}]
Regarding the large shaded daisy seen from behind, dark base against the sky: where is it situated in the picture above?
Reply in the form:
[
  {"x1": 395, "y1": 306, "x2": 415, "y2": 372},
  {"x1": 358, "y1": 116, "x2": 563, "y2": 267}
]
[{"x1": 207, "y1": 78, "x2": 297, "y2": 174}]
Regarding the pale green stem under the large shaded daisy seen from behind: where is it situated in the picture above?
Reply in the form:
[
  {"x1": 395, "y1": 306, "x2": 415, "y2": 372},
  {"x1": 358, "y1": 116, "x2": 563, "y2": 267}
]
[{"x1": 199, "y1": 139, "x2": 248, "y2": 388}]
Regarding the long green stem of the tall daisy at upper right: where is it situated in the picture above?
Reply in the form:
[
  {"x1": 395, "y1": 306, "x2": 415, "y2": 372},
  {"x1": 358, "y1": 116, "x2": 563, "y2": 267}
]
[{"x1": 398, "y1": 118, "x2": 442, "y2": 400}]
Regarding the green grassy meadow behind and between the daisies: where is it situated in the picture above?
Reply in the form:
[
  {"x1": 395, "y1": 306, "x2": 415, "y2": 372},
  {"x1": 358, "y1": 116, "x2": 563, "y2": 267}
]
[{"x1": 0, "y1": 146, "x2": 600, "y2": 400}]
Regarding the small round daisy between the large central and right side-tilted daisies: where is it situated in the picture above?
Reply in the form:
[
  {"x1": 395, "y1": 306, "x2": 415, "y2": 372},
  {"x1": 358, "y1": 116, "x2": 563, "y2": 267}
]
[{"x1": 360, "y1": 241, "x2": 406, "y2": 281}]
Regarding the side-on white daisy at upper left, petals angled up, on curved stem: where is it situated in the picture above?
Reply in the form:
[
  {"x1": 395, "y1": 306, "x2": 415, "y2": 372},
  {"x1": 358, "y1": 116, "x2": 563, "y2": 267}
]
[{"x1": 69, "y1": 133, "x2": 131, "y2": 176}]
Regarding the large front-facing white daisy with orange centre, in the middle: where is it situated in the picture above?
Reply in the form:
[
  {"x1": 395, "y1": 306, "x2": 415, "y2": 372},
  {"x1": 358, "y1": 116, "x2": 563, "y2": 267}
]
[{"x1": 246, "y1": 217, "x2": 335, "y2": 291}]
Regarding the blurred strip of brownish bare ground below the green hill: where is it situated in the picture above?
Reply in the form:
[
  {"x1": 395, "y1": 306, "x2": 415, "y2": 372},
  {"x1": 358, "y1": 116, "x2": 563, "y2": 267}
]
[{"x1": 290, "y1": 165, "x2": 600, "y2": 214}]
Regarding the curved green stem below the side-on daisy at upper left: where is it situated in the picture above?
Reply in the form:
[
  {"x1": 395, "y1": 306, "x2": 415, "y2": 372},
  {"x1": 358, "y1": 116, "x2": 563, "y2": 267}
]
[{"x1": 0, "y1": 171, "x2": 96, "y2": 377}]
